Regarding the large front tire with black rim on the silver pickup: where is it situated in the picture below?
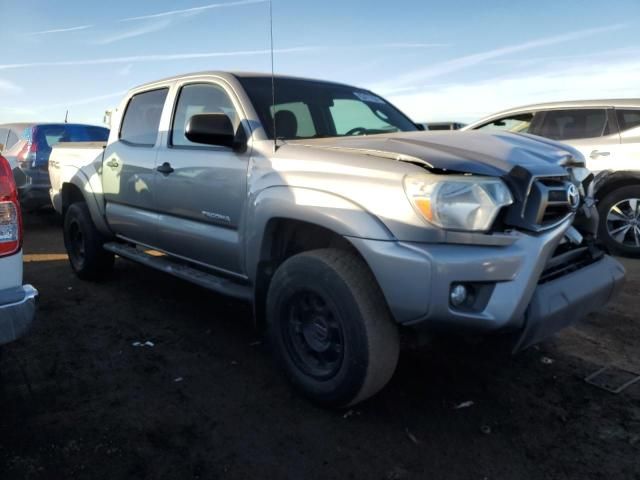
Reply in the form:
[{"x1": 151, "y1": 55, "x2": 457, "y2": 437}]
[{"x1": 267, "y1": 249, "x2": 400, "y2": 407}]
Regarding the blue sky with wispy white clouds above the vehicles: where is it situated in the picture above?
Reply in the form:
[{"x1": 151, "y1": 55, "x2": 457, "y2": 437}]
[{"x1": 0, "y1": 0, "x2": 640, "y2": 124}]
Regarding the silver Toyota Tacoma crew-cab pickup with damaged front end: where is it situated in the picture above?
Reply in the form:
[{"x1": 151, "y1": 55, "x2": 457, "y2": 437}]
[{"x1": 50, "y1": 72, "x2": 624, "y2": 406}]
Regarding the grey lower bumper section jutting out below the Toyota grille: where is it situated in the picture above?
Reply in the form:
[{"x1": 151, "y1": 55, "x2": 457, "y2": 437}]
[{"x1": 513, "y1": 256, "x2": 625, "y2": 354}]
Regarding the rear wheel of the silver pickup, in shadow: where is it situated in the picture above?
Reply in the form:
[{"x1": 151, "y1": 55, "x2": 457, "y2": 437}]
[{"x1": 63, "y1": 202, "x2": 114, "y2": 280}]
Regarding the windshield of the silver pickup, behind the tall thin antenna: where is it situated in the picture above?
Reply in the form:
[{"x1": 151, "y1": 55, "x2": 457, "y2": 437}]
[{"x1": 239, "y1": 77, "x2": 418, "y2": 140}]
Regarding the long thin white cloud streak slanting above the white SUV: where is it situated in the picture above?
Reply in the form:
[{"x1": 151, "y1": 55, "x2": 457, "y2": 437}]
[{"x1": 375, "y1": 24, "x2": 627, "y2": 93}]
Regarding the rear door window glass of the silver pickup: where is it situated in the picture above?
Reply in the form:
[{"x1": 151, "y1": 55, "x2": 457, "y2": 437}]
[{"x1": 120, "y1": 88, "x2": 169, "y2": 147}]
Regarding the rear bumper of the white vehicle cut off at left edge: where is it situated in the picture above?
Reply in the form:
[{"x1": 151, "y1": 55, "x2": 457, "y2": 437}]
[{"x1": 0, "y1": 285, "x2": 38, "y2": 345}]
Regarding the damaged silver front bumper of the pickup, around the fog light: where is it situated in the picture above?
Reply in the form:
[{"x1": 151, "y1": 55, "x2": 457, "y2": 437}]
[{"x1": 349, "y1": 218, "x2": 624, "y2": 349}]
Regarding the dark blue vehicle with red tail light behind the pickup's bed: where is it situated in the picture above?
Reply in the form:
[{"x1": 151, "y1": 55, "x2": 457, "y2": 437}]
[{"x1": 5, "y1": 123, "x2": 109, "y2": 210}]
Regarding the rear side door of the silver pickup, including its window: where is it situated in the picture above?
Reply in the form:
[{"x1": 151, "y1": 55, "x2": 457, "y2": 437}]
[{"x1": 102, "y1": 86, "x2": 169, "y2": 246}]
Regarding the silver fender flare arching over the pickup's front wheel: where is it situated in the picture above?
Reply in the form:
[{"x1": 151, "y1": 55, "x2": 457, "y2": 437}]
[{"x1": 245, "y1": 186, "x2": 394, "y2": 280}]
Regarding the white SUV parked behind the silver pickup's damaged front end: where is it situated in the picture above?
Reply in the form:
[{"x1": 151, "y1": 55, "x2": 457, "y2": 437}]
[{"x1": 465, "y1": 99, "x2": 640, "y2": 256}]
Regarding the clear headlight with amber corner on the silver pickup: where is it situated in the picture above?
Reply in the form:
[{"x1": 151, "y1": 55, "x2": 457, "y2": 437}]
[{"x1": 404, "y1": 175, "x2": 513, "y2": 232}]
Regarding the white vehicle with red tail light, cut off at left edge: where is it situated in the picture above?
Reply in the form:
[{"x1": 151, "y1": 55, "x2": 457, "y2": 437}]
[{"x1": 0, "y1": 156, "x2": 38, "y2": 345}]
